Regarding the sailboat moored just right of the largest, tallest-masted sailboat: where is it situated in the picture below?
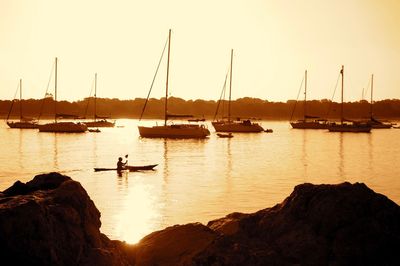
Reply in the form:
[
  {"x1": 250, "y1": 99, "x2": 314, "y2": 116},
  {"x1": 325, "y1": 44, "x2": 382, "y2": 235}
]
[{"x1": 211, "y1": 49, "x2": 264, "y2": 133}]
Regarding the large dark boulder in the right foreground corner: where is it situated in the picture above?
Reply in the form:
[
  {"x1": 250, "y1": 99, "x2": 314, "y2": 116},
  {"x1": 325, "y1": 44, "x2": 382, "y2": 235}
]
[{"x1": 193, "y1": 183, "x2": 400, "y2": 265}]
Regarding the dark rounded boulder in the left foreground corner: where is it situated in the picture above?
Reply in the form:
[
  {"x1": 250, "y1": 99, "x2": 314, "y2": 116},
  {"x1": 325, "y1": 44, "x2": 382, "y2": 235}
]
[{"x1": 0, "y1": 173, "x2": 129, "y2": 265}]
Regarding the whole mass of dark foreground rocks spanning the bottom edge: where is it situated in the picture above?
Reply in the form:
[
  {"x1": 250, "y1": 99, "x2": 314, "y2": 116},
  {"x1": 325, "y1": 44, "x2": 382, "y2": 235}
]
[{"x1": 0, "y1": 173, "x2": 400, "y2": 265}]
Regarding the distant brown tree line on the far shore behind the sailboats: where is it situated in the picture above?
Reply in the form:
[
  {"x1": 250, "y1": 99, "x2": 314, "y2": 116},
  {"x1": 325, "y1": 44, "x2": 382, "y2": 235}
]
[{"x1": 0, "y1": 97, "x2": 400, "y2": 120}]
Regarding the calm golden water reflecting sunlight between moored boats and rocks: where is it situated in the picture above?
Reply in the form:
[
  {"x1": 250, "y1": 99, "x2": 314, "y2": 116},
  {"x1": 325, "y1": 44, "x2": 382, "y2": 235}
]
[{"x1": 0, "y1": 120, "x2": 400, "y2": 243}]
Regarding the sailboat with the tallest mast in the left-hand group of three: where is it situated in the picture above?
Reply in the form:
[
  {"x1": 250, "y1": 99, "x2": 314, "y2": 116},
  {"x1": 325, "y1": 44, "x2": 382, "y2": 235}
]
[{"x1": 39, "y1": 57, "x2": 87, "y2": 133}]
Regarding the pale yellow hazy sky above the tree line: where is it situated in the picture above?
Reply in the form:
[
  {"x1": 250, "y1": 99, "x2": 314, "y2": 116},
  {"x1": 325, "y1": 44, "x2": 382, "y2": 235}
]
[{"x1": 0, "y1": 0, "x2": 400, "y2": 102}]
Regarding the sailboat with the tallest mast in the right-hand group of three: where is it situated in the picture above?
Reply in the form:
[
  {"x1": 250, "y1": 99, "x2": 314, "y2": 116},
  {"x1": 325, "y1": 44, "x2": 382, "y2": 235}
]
[{"x1": 328, "y1": 66, "x2": 371, "y2": 133}]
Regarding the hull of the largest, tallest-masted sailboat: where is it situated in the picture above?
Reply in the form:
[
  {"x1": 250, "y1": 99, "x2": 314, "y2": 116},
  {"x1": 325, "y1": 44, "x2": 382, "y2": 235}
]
[{"x1": 138, "y1": 124, "x2": 210, "y2": 139}]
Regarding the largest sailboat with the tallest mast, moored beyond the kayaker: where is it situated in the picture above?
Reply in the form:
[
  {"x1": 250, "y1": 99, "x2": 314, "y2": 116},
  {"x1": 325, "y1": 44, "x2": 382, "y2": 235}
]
[{"x1": 138, "y1": 30, "x2": 210, "y2": 139}]
